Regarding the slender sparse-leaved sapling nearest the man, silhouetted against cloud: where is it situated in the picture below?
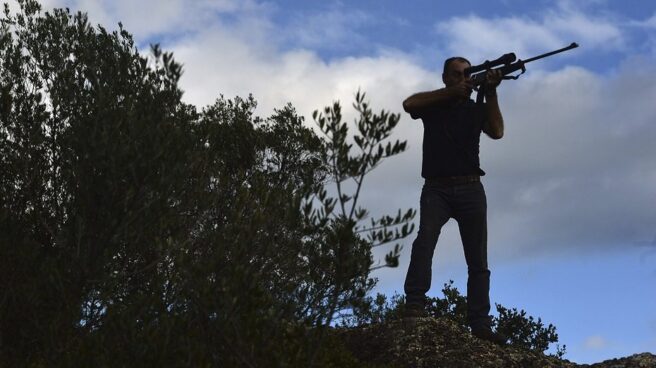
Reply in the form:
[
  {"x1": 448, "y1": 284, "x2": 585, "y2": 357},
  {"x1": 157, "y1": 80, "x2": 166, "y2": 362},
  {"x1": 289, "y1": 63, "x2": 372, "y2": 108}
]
[{"x1": 305, "y1": 91, "x2": 416, "y2": 366}]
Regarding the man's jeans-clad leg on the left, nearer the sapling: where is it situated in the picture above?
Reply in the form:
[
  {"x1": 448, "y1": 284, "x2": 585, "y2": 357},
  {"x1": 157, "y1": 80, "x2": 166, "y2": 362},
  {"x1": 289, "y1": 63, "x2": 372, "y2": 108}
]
[{"x1": 404, "y1": 185, "x2": 451, "y2": 308}]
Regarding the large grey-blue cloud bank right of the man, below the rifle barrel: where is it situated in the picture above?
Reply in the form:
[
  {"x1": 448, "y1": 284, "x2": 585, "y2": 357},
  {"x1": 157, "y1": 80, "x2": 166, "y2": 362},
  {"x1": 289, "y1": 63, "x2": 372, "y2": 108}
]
[{"x1": 482, "y1": 58, "x2": 656, "y2": 251}]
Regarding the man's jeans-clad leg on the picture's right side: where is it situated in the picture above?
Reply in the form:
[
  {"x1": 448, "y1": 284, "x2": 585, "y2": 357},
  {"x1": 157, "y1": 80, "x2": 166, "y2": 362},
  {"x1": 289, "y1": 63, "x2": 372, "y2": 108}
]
[{"x1": 453, "y1": 183, "x2": 491, "y2": 329}]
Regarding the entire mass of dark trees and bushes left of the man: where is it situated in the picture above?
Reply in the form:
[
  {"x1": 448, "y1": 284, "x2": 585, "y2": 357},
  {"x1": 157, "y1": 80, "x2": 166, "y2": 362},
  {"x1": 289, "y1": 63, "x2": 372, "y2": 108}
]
[{"x1": 0, "y1": 0, "x2": 414, "y2": 367}]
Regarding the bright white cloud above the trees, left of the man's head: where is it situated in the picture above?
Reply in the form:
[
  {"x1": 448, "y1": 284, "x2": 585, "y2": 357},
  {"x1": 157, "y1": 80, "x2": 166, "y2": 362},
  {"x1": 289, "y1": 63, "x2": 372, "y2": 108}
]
[{"x1": 171, "y1": 22, "x2": 439, "y2": 131}]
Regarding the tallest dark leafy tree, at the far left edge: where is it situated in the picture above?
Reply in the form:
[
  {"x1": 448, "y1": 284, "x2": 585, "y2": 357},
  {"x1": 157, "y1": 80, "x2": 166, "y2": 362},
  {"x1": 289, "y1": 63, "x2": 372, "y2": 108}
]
[{"x1": 0, "y1": 1, "x2": 198, "y2": 362}]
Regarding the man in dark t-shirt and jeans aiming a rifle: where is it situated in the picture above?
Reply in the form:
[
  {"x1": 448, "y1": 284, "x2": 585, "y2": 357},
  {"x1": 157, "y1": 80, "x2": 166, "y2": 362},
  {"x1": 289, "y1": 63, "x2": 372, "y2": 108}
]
[{"x1": 403, "y1": 57, "x2": 506, "y2": 344}]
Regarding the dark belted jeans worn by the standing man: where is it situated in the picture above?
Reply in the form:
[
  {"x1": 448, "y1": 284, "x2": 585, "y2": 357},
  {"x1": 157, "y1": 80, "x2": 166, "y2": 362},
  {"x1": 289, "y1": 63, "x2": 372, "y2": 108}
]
[{"x1": 404, "y1": 180, "x2": 491, "y2": 328}]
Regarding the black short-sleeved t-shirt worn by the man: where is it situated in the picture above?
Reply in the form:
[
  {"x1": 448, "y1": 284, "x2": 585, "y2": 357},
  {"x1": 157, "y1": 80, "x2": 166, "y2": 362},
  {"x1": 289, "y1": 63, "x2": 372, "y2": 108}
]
[{"x1": 412, "y1": 100, "x2": 486, "y2": 179}]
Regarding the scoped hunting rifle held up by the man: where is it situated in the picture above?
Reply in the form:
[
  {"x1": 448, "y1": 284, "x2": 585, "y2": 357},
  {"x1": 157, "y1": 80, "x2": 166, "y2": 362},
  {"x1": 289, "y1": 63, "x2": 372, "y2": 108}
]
[{"x1": 464, "y1": 42, "x2": 579, "y2": 103}]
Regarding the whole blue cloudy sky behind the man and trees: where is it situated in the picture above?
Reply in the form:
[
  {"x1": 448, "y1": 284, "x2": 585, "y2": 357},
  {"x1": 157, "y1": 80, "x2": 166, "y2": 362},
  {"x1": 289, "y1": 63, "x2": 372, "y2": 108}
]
[{"x1": 24, "y1": 0, "x2": 656, "y2": 363}]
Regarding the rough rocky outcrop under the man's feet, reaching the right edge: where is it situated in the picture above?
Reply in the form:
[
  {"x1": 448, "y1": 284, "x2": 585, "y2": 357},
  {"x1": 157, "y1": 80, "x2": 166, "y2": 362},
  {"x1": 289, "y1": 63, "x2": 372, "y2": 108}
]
[{"x1": 334, "y1": 317, "x2": 656, "y2": 368}]
